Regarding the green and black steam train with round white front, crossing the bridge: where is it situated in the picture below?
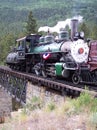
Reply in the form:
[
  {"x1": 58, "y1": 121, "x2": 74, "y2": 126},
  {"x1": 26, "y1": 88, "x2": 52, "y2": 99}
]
[{"x1": 6, "y1": 20, "x2": 97, "y2": 84}]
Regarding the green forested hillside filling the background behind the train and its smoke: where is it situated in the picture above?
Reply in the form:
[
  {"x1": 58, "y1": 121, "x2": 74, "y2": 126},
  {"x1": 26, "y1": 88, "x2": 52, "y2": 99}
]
[{"x1": 0, "y1": 0, "x2": 97, "y2": 63}]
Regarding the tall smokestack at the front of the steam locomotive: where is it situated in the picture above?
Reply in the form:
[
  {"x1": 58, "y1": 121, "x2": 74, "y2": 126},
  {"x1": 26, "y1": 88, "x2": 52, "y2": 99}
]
[{"x1": 71, "y1": 19, "x2": 78, "y2": 40}]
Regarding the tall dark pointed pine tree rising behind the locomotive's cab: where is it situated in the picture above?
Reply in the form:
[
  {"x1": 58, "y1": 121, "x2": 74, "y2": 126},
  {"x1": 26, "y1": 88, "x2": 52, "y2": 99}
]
[{"x1": 26, "y1": 11, "x2": 37, "y2": 34}]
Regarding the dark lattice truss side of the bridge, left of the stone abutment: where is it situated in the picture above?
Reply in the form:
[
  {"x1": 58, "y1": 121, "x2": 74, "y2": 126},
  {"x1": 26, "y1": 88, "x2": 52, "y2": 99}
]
[{"x1": 0, "y1": 69, "x2": 27, "y2": 104}]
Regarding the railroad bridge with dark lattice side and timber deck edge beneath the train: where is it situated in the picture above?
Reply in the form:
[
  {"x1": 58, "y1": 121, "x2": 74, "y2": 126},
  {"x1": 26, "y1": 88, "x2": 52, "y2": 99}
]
[{"x1": 0, "y1": 66, "x2": 97, "y2": 105}]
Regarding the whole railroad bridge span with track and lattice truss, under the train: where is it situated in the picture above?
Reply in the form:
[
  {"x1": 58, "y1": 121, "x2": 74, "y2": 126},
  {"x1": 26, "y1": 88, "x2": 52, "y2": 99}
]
[{"x1": 0, "y1": 66, "x2": 97, "y2": 103}]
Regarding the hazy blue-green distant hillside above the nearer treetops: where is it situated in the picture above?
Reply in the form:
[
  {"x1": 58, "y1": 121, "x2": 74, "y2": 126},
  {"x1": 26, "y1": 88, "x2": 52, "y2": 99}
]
[{"x1": 0, "y1": 0, "x2": 97, "y2": 31}]
